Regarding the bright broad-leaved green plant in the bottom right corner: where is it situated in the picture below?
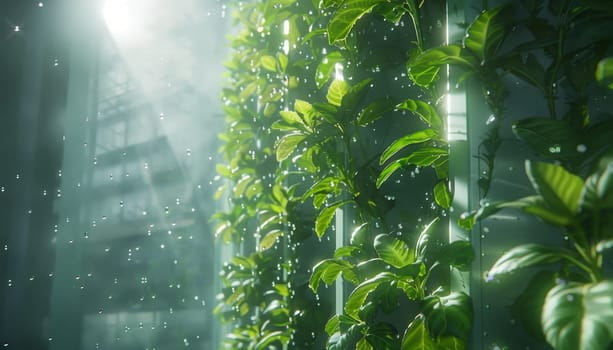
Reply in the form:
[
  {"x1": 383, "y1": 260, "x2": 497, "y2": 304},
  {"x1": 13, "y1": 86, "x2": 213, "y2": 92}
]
[{"x1": 462, "y1": 161, "x2": 613, "y2": 350}]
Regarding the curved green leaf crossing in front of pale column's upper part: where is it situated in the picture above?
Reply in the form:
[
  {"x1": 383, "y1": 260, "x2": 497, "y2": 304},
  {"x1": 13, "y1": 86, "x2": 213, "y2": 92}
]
[{"x1": 407, "y1": 44, "x2": 477, "y2": 87}]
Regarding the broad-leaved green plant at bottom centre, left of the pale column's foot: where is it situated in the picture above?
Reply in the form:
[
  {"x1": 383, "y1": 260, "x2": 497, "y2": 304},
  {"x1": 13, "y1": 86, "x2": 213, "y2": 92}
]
[{"x1": 309, "y1": 218, "x2": 473, "y2": 349}]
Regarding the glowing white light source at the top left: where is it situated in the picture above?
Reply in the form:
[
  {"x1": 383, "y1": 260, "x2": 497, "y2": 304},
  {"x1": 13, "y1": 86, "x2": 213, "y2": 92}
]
[{"x1": 102, "y1": 0, "x2": 142, "y2": 39}]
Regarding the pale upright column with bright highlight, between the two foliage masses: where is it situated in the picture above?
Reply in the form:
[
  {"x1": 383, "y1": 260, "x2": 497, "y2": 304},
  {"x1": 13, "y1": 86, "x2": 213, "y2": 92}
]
[{"x1": 447, "y1": 0, "x2": 483, "y2": 349}]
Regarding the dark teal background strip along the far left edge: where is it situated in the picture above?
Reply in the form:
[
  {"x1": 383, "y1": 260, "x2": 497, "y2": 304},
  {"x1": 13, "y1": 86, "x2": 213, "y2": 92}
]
[{"x1": 0, "y1": 0, "x2": 72, "y2": 349}]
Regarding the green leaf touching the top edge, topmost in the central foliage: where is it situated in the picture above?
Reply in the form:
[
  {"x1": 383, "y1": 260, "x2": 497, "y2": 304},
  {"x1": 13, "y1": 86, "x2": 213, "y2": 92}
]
[{"x1": 328, "y1": 0, "x2": 385, "y2": 44}]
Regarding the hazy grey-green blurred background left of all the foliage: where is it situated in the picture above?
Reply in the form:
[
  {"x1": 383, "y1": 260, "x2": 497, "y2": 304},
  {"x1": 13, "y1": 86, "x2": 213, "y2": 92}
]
[{"x1": 0, "y1": 0, "x2": 228, "y2": 350}]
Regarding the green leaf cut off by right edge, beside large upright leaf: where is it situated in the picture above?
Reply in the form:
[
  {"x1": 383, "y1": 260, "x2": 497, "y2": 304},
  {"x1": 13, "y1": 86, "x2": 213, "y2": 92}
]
[{"x1": 579, "y1": 163, "x2": 613, "y2": 210}]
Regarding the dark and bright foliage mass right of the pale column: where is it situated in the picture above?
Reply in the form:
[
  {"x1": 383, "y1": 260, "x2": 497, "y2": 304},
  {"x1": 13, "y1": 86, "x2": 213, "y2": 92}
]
[{"x1": 438, "y1": 0, "x2": 613, "y2": 350}]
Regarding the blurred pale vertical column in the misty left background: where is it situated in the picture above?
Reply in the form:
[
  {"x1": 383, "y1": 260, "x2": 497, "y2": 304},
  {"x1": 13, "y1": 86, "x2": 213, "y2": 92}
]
[{"x1": 49, "y1": 0, "x2": 98, "y2": 350}]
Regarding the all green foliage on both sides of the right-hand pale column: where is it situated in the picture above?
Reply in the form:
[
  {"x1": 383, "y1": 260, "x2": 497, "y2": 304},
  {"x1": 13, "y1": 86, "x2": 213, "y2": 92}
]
[{"x1": 216, "y1": 0, "x2": 613, "y2": 349}]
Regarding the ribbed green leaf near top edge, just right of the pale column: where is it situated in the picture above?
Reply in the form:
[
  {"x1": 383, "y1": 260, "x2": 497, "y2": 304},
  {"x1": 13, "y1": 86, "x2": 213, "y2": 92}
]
[{"x1": 464, "y1": 5, "x2": 509, "y2": 63}]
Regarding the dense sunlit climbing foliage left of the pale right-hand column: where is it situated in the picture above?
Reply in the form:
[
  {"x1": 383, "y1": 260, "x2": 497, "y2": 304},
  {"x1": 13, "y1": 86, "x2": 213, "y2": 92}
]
[{"x1": 215, "y1": 0, "x2": 473, "y2": 349}]
